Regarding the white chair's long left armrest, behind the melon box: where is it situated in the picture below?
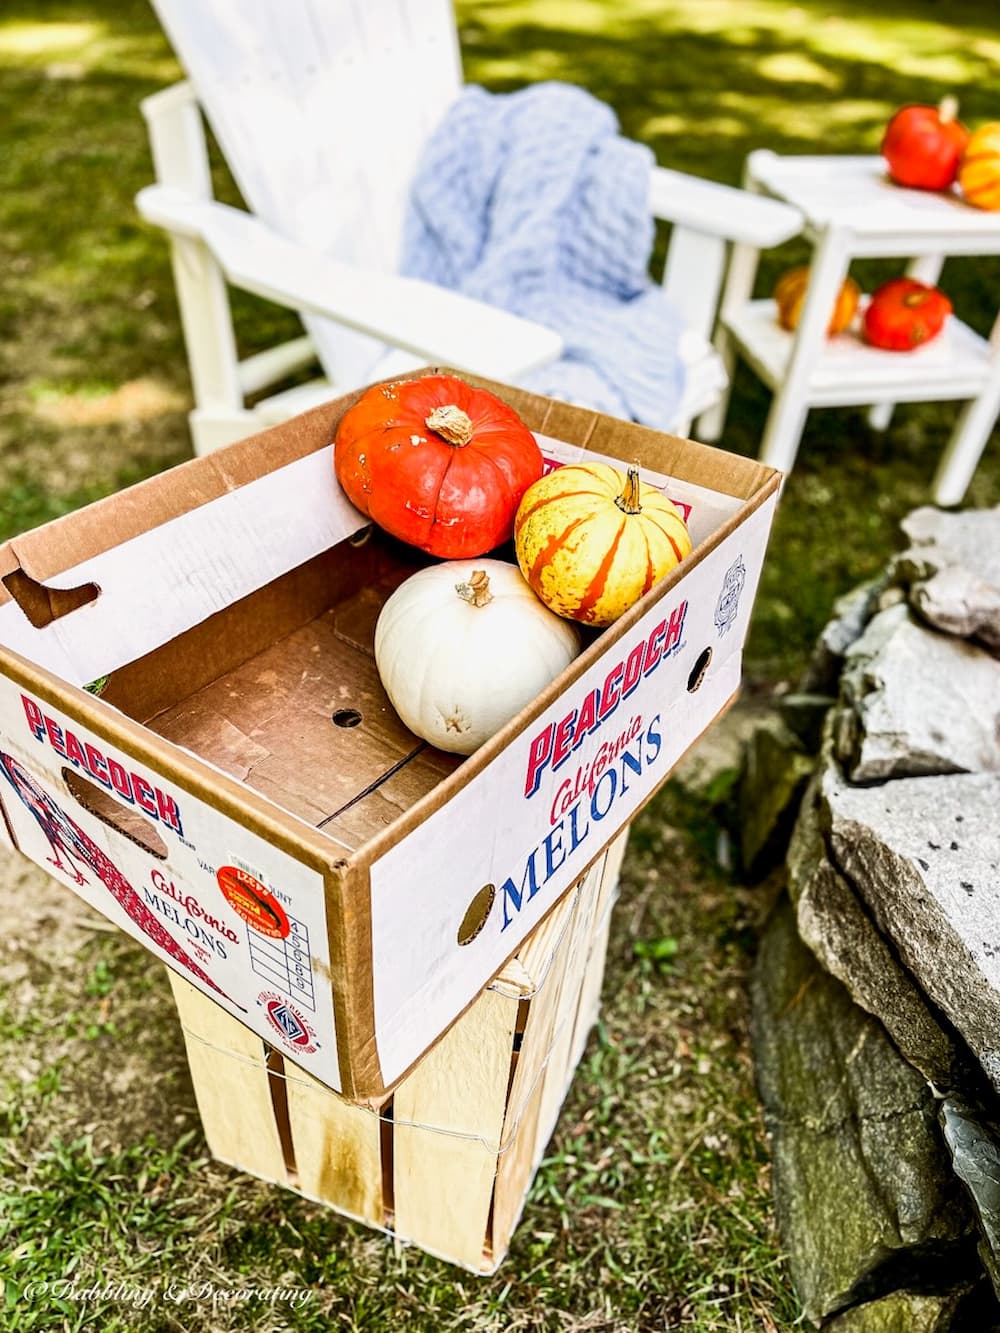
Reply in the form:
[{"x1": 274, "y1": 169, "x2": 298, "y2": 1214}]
[{"x1": 136, "y1": 185, "x2": 563, "y2": 380}]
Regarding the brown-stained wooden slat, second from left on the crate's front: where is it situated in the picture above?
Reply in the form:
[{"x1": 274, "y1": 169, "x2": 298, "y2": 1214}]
[{"x1": 285, "y1": 1066, "x2": 385, "y2": 1226}]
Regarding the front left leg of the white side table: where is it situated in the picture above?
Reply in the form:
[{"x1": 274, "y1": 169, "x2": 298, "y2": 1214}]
[{"x1": 760, "y1": 228, "x2": 849, "y2": 472}]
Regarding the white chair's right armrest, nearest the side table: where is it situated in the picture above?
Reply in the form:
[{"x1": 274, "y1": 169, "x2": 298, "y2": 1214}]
[{"x1": 649, "y1": 167, "x2": 805, "y2": 249}]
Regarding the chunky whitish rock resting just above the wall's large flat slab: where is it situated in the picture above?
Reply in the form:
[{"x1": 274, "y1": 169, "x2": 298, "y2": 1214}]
[{"x1": 837, "y1": 604, "x2": 1000, "y2": 782}]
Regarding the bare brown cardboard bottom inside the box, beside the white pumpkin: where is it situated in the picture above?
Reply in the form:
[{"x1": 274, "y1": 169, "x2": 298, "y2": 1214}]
[{"x1": 104, "y1": 532, "x2": 463, "y2": 850}]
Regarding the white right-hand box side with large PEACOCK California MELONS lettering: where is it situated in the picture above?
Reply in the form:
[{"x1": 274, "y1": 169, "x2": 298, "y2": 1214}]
[{"x1": 371, "y1": 497, "x2": 775, "y2": 1082}]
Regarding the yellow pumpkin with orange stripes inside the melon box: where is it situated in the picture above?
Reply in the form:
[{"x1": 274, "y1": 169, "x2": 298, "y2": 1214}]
[{"x1": 513, "y1": 463, "x2": 691, "y2": 625}]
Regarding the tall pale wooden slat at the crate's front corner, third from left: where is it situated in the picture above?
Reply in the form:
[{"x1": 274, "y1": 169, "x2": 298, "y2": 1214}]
[{"x1": 393, "y1": 990, "x2": 519, "y2": 1272}]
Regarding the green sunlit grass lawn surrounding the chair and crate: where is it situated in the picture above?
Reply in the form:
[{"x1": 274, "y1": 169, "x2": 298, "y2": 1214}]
[{"x1": 0, "y1": 0, "x2": 1000, "y2": 1333}]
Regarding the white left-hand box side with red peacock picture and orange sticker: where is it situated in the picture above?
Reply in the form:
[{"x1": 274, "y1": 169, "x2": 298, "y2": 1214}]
[{"x1": 0, "y1": 693, "x2": 341, "y2": 1089}]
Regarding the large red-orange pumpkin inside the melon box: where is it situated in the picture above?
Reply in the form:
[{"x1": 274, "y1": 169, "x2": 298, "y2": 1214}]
[{"x1": 333, "y1": 375, "x2": 544, "y2": 560}]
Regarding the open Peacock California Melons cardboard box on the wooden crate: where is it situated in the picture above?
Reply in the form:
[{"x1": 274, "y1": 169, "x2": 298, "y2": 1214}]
[{"x1": 0, "y1": 381, "x2": 779, "y2": 1098}]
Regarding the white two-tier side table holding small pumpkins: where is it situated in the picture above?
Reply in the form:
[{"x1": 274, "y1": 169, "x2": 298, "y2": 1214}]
[{"x1": 697, "y1": 149, "x2": 1000, "y2": 505}]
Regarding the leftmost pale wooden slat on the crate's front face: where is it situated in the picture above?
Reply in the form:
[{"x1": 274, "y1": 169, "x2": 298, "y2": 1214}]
[{"x1": 167, "y1": 970, "x2": 289, "y2": 1185}]
